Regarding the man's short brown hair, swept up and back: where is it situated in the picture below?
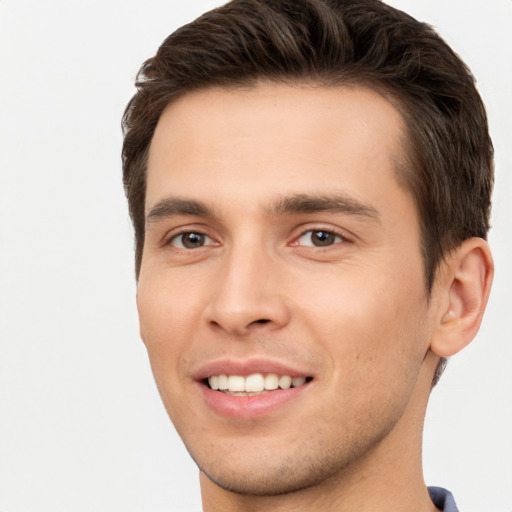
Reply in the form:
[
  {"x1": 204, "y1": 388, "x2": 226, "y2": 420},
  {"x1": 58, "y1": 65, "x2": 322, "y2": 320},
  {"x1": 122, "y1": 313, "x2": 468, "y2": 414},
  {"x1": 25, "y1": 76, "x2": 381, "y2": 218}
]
[{"x1": 122, "y1": 0, "x2": 493, "y2": 292}]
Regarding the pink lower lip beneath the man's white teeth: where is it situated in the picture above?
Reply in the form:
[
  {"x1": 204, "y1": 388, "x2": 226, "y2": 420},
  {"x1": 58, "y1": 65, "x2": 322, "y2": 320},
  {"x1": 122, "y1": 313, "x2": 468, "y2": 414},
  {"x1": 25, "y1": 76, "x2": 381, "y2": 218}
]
[{"x1": 198, "y1": 383, "x2": 311, "y2": 419}]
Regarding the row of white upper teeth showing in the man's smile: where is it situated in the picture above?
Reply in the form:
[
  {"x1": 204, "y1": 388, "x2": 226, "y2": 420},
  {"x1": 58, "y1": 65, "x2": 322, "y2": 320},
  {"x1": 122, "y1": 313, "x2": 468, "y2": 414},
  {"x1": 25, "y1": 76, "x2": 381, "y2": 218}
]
[{"x1": 208, "y1": 373, "x2": 306, "y2": 394}]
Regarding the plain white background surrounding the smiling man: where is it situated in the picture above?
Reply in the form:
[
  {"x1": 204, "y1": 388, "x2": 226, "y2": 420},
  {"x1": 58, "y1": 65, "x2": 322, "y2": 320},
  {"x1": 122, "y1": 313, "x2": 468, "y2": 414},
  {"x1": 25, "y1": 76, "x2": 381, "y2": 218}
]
[{"x1": 0, "y1": 0, "x2": 512, "y2": 512}]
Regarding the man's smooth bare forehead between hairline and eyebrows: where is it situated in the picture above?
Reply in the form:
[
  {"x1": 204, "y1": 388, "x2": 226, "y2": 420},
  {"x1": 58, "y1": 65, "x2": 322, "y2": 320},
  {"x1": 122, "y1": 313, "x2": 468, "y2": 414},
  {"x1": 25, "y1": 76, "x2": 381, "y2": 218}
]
[{"x1": 146, "y1": 83, "x2": 404, "y2": 212}]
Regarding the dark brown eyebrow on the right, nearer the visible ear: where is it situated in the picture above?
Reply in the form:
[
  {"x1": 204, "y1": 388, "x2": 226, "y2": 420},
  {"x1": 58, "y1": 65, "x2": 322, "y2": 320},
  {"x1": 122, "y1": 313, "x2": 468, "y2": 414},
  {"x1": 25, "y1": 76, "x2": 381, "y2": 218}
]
[{"x1": 267, "y1": 194, "x2": 380, "y2": 221}]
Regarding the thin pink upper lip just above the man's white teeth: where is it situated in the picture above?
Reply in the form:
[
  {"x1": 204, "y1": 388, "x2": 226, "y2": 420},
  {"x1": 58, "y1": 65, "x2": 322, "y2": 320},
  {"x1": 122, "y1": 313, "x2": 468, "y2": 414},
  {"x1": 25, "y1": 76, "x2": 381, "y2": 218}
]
[{"x1": 192, "y1": 358, "x2": 313, "y2": 381}]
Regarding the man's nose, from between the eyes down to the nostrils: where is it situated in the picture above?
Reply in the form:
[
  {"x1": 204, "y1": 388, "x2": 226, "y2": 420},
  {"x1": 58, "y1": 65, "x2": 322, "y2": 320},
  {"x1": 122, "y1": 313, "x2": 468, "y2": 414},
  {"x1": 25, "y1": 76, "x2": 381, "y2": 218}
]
[{"x1": 206, "y1": 246, "x2": 290, "y2": 336}]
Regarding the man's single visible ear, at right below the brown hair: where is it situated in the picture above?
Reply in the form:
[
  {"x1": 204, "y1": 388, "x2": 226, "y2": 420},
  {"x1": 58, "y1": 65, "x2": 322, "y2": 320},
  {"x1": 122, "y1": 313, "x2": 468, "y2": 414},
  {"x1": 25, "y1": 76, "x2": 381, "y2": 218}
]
[{"x1": 430, "y1": 238, "x2": 494, "y2": 357}]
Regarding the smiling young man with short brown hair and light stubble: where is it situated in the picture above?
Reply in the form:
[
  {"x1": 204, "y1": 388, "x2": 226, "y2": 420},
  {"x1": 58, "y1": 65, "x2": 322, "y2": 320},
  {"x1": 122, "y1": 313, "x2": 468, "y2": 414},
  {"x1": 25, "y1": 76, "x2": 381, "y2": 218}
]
[{"x1": 123, "y1": 0, "x2": 493, "y2": 512}]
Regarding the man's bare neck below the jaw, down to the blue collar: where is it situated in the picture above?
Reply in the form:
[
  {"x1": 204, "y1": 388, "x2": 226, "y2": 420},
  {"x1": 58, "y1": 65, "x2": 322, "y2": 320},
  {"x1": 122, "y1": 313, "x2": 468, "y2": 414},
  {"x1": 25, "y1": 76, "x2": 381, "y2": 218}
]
[{"x1": 200, "y1": 352, "x2": 438, "y2": 512}]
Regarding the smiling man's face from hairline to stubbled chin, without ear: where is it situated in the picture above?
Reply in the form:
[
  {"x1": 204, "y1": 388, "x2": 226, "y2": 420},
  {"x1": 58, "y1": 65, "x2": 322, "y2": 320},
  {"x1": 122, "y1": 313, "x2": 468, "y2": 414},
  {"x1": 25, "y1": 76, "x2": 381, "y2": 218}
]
[{"x1": 137, "y1": 83, "x2": 429, "y2": 494}]
